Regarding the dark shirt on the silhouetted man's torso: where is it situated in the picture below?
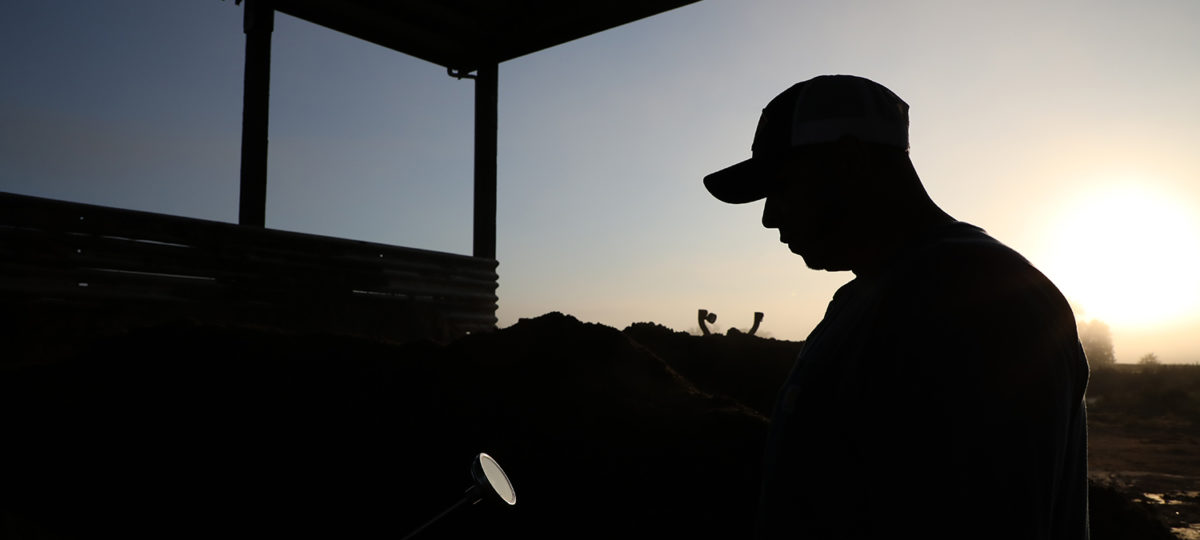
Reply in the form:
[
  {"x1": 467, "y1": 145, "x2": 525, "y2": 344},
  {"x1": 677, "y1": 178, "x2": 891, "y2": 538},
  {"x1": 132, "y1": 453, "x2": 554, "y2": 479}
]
[{"x1": 758, "y1": 222, "x2": 1088, "y2": 540}]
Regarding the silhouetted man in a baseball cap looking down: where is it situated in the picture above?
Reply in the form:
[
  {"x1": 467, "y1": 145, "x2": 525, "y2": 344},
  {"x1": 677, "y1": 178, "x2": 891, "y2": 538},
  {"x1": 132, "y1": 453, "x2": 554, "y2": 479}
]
[{"x1": 704, "y1": 76, "x2": 1088, "y2": 539}]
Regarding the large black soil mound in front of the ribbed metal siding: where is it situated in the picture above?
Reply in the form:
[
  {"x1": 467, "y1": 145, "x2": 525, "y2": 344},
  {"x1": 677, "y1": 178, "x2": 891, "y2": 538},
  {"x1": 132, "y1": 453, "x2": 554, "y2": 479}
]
[{"x1": 0, "y1": 313, "x2": 766, "y2": 539}]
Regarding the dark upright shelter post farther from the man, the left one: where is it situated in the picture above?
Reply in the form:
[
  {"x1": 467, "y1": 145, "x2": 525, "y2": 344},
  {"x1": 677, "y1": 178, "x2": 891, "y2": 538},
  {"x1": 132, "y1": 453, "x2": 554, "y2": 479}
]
[{"x1": 238, "y1": 0, "x2": 275, "y2": 227}]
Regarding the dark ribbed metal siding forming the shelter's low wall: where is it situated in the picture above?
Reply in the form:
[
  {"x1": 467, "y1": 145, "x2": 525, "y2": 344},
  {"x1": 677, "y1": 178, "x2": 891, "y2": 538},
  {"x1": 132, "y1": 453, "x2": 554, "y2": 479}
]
[{"x1": 0, "y1": 193, "x2": 498, "y2": 338}]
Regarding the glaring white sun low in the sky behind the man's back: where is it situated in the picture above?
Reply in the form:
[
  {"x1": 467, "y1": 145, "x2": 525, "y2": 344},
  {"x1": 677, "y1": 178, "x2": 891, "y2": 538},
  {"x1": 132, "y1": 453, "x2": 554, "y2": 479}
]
[{"x1": 1043, "y1": 184, "x2": 1200, "y2": 328}]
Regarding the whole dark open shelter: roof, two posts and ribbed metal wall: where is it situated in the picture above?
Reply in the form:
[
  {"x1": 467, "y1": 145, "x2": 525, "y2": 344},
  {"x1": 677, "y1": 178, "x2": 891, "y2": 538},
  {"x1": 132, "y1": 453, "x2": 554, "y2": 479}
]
[{"x1": 0, "y1": 0, "x2": 698, "y2": 338}]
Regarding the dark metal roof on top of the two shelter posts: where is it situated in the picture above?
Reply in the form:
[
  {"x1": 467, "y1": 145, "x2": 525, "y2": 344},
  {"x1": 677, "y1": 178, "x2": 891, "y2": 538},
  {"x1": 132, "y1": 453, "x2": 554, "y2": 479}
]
[{"x1": 274, "y1": 0, "x2": 698, "y2": 72}]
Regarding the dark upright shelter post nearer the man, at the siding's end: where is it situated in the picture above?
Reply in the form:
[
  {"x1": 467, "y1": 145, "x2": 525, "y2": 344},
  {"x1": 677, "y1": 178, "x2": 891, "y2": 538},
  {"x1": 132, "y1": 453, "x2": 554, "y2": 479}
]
[{"x1": 473, "y1": 64, "x2": 499, "y2": 259}]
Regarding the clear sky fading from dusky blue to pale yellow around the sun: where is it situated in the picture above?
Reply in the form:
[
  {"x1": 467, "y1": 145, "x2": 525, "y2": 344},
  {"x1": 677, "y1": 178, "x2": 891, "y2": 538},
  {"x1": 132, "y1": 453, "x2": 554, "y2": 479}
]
[{"x1": 0, "y1": 0, "x2": 1200, "y2": 362}]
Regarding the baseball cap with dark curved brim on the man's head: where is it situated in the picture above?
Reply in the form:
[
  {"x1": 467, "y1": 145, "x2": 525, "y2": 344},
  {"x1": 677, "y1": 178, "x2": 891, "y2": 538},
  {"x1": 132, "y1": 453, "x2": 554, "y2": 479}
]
[{"x1": 704, "y1": 74, "x2": 908, "y2": 204}]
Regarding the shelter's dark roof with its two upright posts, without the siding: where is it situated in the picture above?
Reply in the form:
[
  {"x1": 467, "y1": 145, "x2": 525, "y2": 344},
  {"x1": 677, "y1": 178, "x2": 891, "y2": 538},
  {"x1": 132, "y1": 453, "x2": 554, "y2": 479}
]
[{"x1": 239, "y1": 0, "x2": 698, "y2": 258}]
